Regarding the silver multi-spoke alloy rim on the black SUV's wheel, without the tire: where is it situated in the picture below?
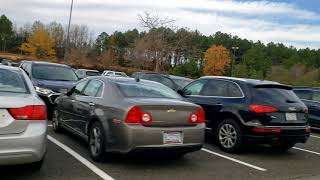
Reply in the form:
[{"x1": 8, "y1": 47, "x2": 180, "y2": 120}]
[{"x1": 219, "y1": 124, "x2": 237, "y2": 148}]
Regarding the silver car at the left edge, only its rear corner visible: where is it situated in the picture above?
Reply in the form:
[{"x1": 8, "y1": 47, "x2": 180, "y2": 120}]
[{"x1": 0, "y1": 65, "x2": 47, "y2": 168}]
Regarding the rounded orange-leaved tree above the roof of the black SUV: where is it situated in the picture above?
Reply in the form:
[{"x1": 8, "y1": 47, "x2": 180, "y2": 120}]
[{"x1": 203, "y1": 45, "x2": 231, "y2": 76}]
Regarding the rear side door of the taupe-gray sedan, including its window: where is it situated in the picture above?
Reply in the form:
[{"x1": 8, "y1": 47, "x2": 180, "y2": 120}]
[{"x1": 73, "y1": 79, "x2": 104, "y2": 133}]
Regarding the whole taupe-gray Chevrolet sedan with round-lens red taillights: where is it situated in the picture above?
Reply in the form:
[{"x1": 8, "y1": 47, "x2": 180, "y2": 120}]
[{"x1": 53, "y1": 76, "x2": 205, "y2": 160}]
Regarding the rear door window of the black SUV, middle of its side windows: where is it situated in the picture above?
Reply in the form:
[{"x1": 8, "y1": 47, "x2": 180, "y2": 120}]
[{"x1": 201, "y1": 80, "x2": 229, "y2": 97}]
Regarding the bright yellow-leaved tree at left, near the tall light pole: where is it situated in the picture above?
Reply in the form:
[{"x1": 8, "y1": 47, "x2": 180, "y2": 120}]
[{"x1": 20, "y1": 28, "x2": 56, "y2": 59}]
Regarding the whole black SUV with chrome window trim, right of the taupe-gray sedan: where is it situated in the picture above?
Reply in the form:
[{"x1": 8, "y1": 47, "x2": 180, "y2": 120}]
[{"x1": 178, "y1": 77, "x2": 310, "y2": 153}]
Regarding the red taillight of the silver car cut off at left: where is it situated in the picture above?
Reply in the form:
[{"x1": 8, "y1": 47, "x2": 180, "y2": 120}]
[{"x1": 8, "y1": 105, "x2": 48, "y2": 120}]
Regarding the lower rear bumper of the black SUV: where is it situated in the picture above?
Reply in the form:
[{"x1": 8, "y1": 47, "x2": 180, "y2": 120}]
[{"x1": 244, "y1": 126, "x2": 310, "y2": 144}]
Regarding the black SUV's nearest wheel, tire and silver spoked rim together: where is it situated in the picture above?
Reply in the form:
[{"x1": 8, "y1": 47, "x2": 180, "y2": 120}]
[{"x1": 216, "y1": 119, "x2": 245, "y2": 153}]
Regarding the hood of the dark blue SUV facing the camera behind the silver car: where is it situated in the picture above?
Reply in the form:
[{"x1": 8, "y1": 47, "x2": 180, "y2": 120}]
[{"x1": 33, "y1": 79, "x2": 76, "y2": 92}]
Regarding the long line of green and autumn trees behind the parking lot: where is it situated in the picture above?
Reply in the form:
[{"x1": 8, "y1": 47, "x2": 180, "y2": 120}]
[{"x1": 0, "y1": 12, "x2": 320, "y2": 86}]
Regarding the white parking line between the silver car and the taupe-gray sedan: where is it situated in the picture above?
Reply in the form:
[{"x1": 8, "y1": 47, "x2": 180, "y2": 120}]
[{"x1": 47, "y1": 135, "x2": 113, "y2": 180}]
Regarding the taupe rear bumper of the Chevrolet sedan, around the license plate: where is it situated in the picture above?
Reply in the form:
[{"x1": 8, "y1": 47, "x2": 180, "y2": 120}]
[{"x1": 109, "y1": 124, "x2": 205, "y2": 153}]
